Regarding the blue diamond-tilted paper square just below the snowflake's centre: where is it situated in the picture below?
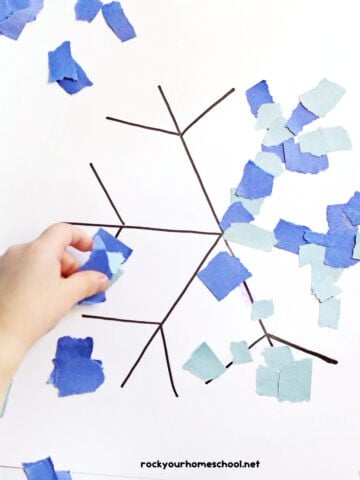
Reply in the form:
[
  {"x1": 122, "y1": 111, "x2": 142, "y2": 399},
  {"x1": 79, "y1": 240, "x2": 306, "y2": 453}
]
[{"x1": 197, "y1": 252, "x2": 251, "y2": 300}]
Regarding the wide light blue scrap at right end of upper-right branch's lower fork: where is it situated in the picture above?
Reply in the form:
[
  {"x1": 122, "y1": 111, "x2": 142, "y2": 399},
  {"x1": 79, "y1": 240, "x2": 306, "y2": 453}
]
[{"x1": 299, "y1": 127, "x2": 351, "y2": 156}]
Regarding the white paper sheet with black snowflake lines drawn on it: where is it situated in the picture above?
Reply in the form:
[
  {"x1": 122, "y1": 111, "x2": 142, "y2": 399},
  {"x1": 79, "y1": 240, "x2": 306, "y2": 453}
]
[{"x1": 0, "y1": 0, "x2": 360, "y2": 480}]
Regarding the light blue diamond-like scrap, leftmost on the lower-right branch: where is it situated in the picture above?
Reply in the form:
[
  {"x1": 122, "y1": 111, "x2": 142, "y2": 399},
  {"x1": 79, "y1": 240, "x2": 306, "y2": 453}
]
[{"x1": 183, "y1": 342, "x2": 226, "y2": 382}]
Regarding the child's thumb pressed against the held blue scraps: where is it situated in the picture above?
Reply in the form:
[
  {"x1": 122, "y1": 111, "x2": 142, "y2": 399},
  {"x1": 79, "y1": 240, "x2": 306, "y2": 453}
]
[{"x1": 64, "y1": 270, "x2": 110, "y2": 305}]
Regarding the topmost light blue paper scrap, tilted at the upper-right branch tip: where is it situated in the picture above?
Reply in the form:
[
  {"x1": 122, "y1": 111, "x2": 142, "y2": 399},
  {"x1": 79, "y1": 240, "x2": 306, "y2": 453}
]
[{"x1": 299, "y1": 78, "x2": 345, "y2": 117}]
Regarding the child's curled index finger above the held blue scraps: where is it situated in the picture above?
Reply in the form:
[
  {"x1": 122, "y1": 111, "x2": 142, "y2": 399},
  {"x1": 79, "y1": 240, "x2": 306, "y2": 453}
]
[{"x1": 37, "y1": 223, "x2": 93, "y2": 258}]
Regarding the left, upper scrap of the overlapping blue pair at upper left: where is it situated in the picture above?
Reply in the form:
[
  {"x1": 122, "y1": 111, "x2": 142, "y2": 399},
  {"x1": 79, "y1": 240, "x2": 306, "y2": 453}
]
[{"x1": 48, "y1": 41, "x2": 78, "y2": 82}]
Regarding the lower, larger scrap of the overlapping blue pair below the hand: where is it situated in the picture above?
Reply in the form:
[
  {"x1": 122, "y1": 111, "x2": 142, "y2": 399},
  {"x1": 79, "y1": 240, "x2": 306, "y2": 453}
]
[{"x1": 51, "y1": 358, "x2": 105, "y2": 397}]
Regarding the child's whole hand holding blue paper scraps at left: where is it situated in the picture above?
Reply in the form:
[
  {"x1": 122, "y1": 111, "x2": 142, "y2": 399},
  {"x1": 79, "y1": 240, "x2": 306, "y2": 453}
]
[{"x1": 0, "y1": 223, "x2": 109, "y2": 404}]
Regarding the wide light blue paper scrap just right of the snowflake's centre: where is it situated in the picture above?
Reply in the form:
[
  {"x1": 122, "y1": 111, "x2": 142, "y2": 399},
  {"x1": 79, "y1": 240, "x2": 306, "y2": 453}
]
[{"x1": 224, "y1": 223, "x2": 276, "y2": 252}]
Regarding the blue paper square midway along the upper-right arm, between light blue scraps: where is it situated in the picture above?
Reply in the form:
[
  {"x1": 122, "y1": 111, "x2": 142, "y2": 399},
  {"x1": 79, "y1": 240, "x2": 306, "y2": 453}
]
[{"x1": 236, "y1": 160, "x2": 274, "y2": 200}]
